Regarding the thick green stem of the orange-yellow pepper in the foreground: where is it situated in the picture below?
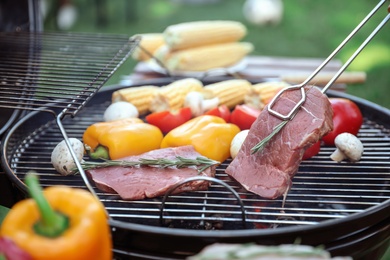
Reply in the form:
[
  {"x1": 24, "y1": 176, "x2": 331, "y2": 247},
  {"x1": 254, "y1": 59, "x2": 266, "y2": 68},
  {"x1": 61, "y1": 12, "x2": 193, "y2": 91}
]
[{"x1": 25, "y1": 174, "x2": 69, "y2": 237}]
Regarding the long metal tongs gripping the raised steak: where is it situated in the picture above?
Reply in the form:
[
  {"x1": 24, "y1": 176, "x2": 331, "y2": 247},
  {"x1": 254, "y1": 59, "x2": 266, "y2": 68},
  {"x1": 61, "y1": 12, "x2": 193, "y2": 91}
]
[{"x1": 268, "y1": 0, "x2": 390, "y2": 121}]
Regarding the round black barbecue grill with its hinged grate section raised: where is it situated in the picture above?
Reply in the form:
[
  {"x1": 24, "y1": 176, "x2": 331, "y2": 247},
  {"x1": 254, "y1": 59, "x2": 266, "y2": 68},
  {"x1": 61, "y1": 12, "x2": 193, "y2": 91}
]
[{"x1": 0, "y1": 0, "x2": 390, "y2": 259}]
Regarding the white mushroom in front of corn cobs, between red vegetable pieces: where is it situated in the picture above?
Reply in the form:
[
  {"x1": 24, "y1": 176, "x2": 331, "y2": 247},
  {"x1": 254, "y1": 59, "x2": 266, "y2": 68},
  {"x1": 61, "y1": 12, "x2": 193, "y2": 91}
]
[{"x1": 184, "y1": 91, "x2": 219, "y2": 116}]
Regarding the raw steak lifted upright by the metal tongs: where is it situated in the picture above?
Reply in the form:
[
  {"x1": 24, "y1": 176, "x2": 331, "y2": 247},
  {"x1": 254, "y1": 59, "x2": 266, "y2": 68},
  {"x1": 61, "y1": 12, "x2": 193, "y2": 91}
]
[{"x1": 226, "y1": 86, "x2": 333, "y2": 199}]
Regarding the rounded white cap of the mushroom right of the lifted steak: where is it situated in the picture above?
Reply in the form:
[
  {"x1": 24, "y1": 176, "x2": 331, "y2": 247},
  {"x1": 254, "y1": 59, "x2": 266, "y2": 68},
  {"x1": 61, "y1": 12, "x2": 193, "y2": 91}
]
[{"x1": 334, "y1": 133, "x2": 364, "y2": 162}]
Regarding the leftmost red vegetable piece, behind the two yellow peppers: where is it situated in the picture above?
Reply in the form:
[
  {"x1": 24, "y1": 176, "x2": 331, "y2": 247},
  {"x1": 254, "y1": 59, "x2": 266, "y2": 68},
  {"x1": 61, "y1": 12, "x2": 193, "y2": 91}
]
[{"x1": 145, "y1": 107, "x2": 192, "y2": 134}]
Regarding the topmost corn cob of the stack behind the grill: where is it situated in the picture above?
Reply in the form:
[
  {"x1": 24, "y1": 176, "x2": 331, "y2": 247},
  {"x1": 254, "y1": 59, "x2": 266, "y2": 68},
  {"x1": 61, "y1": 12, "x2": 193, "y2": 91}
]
[{"x1": 163, "y1": 21, "x2": 247, "y2": 50}]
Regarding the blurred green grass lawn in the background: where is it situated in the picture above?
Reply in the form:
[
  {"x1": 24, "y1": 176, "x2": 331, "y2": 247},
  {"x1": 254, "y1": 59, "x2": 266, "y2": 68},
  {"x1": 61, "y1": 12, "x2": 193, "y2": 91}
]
[{"x1": 45, "y1": 0, "x2": 390, "y2": 259}]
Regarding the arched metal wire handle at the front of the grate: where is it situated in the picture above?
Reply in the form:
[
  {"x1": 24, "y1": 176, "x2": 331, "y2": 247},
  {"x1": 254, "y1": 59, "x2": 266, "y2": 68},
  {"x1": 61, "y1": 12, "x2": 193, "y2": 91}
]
[{"x1": 160, "y1": 176, "x2": 246, "y2": 228}]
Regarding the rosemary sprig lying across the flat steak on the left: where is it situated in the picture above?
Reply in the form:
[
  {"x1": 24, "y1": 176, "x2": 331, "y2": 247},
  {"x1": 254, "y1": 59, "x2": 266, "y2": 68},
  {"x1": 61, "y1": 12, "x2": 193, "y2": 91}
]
[{"x1": 74, "y1": 156, "x2": 220, "y2": 173}]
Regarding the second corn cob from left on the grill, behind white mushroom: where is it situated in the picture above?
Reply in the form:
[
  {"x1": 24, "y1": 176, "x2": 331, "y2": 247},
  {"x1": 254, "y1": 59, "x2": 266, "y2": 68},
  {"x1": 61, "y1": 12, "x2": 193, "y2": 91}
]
[{"x1": 149, "y1": 78, "x2": 203, "y2": 112}]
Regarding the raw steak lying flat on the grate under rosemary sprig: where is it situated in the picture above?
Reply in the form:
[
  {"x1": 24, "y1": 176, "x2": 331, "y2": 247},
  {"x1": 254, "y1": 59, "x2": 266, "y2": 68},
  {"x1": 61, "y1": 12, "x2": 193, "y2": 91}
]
[{"x1": 86, "y1": 146, "x2": 216, "y2": 200}]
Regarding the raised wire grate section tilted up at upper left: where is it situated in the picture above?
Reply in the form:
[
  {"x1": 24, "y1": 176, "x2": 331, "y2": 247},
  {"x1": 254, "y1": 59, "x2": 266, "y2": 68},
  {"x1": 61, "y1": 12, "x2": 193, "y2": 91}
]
[{"x1": 0, "y1": 32, "x2": 137, "y2": 116}]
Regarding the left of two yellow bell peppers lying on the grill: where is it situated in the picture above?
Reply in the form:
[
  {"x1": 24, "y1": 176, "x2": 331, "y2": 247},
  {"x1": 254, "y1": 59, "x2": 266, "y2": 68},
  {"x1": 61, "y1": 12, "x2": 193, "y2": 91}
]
[{"x1": 83, "y1": 118, "x2": 163, "y2": 160}]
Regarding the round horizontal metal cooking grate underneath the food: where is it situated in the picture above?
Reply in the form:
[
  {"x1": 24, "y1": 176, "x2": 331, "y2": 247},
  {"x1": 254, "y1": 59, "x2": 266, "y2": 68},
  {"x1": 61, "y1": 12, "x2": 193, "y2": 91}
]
[{"x1": 6, "y1": 88, "x2": 390, "y2": 230}]
